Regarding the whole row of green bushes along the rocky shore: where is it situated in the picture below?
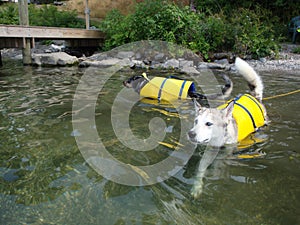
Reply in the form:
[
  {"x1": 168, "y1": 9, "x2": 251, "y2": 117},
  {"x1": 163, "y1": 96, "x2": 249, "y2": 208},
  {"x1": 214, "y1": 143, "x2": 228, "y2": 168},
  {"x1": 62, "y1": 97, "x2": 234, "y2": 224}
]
[{"x1": 100, "y1": 0, "x2": 278, "y2": 58}]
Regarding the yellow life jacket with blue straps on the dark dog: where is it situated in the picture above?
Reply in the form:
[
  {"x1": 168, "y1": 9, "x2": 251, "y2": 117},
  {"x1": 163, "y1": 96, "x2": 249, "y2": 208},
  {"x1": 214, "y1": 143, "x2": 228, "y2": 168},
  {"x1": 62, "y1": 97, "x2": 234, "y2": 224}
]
[{"x1": 140, "y1": 77, "x2": 193, "y2": 101}]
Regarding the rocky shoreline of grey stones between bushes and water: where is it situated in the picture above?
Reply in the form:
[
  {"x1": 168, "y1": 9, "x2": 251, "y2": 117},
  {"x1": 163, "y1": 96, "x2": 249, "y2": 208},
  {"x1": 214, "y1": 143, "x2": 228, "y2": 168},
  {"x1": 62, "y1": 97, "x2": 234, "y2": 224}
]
[{"x1": 1, "y1": 40, "x2": 300, "y2": 73}]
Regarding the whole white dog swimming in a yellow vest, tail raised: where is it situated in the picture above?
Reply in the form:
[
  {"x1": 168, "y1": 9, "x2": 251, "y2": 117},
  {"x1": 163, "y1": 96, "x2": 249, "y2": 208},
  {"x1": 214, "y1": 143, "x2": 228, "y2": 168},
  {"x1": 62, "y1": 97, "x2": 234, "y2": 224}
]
[{"x1": 188, "y1": 58, "x2": 268, "y2": 197}]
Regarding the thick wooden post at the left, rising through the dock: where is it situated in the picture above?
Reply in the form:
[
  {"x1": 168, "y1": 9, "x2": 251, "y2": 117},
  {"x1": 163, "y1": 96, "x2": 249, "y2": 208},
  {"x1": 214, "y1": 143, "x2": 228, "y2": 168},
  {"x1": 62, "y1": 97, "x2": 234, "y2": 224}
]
[{"x1": 18, "y1": 0, "x2": 32, "y2": 65}]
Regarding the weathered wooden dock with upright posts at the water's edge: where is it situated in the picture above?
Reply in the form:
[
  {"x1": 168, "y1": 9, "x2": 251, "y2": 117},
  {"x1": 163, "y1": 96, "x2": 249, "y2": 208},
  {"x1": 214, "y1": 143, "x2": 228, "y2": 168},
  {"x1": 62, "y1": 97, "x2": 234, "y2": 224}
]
[{"x1": 0, "y1": 0, "x2": 104, "y2": 66}]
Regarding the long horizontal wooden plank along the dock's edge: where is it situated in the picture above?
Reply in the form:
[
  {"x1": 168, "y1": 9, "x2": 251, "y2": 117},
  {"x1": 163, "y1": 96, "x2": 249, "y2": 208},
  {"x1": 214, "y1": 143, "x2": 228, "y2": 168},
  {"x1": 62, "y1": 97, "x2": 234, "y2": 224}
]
[{"x1": 0, "y1": 25, "x2": 104, "y2": 39}]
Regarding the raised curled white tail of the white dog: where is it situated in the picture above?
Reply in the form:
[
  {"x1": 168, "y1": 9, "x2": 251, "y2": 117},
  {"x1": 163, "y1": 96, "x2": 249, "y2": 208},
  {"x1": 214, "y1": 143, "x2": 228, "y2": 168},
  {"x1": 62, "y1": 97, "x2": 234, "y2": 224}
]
[{"x1": 235, "y1": 57, "x2": 264, "y2": 101}]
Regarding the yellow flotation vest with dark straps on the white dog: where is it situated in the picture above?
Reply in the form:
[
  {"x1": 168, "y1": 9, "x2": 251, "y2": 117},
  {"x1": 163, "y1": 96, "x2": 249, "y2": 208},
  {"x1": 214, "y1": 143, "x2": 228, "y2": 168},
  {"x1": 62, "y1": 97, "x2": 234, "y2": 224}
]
[{"x1": 218, "y1": 94, "x2": 266, "y2": 142}]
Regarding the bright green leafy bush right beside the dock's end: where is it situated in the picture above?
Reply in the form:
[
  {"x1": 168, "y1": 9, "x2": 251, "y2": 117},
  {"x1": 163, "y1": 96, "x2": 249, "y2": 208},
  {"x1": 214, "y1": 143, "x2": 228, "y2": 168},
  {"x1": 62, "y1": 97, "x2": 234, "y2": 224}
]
[{"x1": 100, "y1": 0, "x2": 195, "y2": 48}]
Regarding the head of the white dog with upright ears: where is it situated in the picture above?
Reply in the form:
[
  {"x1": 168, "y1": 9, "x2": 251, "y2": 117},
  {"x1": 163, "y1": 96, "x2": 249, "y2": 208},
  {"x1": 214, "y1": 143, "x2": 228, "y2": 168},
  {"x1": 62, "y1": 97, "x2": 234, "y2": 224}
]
[{"x1": 188, "y1": 101, "x2": 235, "y2": 147}]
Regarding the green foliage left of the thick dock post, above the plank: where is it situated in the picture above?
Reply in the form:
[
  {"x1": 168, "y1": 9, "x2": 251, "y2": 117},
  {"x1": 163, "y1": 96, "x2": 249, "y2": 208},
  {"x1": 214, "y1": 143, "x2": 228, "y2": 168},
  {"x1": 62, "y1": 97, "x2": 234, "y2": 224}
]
[{"x1": 0, "y1": 4, "x2": 19, "y2": 25}]
